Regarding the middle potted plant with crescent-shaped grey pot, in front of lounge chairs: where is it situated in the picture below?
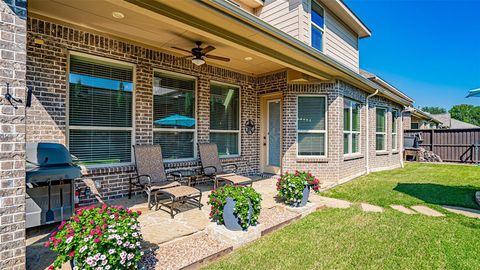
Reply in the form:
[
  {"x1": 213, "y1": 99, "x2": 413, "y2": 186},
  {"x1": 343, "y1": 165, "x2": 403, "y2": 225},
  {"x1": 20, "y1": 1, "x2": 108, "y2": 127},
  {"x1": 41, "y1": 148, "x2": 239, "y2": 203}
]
[{"x1": 208, "y1": 185, "x2": 262, "y2": 231}]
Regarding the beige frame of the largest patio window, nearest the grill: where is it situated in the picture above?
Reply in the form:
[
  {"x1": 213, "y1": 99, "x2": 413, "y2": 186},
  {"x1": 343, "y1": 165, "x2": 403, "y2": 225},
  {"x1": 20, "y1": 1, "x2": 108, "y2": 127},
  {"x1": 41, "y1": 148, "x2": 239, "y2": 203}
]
[{"x1": 65, "y1": 50, "x2": 137, "y2": 168}]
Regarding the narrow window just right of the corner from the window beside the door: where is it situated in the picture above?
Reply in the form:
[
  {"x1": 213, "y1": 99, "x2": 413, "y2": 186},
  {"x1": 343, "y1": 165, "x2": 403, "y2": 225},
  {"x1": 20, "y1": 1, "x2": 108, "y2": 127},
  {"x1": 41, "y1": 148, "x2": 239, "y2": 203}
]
[{"x1": 343, "y1": 99, "x2": 360, "y2": 155}]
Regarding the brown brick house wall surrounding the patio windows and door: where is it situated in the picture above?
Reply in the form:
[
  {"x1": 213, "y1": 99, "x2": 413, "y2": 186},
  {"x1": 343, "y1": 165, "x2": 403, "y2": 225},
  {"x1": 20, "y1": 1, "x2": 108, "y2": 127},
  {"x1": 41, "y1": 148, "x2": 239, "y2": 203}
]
[{"x1": 27, "y1": 18, "x2": 400, "y2": 203}]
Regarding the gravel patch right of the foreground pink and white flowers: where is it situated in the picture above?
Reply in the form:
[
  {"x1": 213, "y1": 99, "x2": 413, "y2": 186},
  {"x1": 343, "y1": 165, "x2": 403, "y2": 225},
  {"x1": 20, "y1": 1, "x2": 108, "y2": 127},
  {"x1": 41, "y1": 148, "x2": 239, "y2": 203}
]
[{"x1": 152, "y1": 233, "x2": 230, "y2": 269}]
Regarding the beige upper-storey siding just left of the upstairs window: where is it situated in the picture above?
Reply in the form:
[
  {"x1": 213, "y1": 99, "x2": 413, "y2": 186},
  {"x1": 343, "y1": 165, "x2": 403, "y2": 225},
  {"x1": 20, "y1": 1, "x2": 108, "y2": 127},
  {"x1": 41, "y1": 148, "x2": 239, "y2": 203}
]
[{"x1": 257, "y1": 0, "x2": 306, "y2": 38}]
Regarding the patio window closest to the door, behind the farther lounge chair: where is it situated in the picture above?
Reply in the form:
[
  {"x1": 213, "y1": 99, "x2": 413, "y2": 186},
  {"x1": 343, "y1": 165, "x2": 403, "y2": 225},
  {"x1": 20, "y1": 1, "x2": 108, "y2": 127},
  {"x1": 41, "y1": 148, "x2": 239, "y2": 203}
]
[{"x1": 210, "y1": 83, "x2": 240, "y2": 157}]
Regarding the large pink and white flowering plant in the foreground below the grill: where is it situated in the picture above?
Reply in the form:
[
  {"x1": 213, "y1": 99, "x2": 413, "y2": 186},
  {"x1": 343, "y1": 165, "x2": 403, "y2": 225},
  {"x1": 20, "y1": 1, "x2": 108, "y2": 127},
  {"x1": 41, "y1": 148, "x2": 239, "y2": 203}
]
[{"x1": 45, "y1": 204, "x2": 143, "y2": 270}]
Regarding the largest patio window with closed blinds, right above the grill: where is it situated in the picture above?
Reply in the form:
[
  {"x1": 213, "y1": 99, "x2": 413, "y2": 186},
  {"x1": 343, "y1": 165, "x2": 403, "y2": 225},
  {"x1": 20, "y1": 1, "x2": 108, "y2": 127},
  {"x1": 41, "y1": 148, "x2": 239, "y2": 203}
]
[{"x1": 68, "y1": 55, "x2": 134, "y2": 165}]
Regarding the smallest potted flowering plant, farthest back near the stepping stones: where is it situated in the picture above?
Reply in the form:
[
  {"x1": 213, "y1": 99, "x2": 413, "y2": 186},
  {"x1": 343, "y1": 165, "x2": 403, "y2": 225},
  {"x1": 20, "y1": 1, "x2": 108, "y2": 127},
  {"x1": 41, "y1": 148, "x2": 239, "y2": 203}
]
[{"x1": 277, "y1": 171, "x2": 320, "y2": 207}]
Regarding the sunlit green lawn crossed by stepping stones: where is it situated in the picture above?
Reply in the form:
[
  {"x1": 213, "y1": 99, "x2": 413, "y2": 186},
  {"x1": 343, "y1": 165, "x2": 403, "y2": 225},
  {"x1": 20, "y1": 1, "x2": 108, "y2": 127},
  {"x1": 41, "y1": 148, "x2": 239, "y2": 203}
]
[{"x1": 207, "y1": 164, "x2": 480, "y2": 270}]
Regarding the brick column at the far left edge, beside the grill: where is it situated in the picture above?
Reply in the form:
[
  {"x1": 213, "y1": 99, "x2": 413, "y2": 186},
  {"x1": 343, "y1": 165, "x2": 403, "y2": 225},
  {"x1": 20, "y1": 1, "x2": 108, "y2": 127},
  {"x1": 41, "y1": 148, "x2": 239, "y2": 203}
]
[{"x1": 0, "y1": 0, "x2": 26, "y2": 270}]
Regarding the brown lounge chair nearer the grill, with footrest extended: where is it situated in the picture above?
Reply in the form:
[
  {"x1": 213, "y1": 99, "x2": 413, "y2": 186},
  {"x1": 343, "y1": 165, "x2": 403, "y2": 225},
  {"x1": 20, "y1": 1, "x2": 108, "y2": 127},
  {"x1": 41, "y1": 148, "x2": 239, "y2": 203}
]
[{"x1": 129, "y1": 145, "x2": 202, "y2": 218}]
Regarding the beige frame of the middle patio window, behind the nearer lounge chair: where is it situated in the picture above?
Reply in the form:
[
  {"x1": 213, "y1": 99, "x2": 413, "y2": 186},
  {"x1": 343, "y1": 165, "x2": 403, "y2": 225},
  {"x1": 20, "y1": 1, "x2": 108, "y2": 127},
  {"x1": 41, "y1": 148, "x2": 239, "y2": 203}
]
[{"x1": 151, "y1": 68, "x2": 198, "y2": 163}]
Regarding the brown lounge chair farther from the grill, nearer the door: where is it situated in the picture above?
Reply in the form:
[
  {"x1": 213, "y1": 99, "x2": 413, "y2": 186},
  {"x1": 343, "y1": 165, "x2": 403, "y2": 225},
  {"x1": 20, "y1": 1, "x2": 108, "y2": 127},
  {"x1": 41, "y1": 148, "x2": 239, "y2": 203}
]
[{"x1": 198, "y1": 143, "x2": 253, "y2": 188}]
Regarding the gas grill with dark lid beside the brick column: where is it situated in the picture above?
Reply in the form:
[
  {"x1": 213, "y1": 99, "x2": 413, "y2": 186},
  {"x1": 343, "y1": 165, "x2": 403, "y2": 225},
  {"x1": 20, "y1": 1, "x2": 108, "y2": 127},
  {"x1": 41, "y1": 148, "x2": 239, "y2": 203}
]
[{"x1": 26, "y1": 143, "x2": 81, "y2": 228}]
